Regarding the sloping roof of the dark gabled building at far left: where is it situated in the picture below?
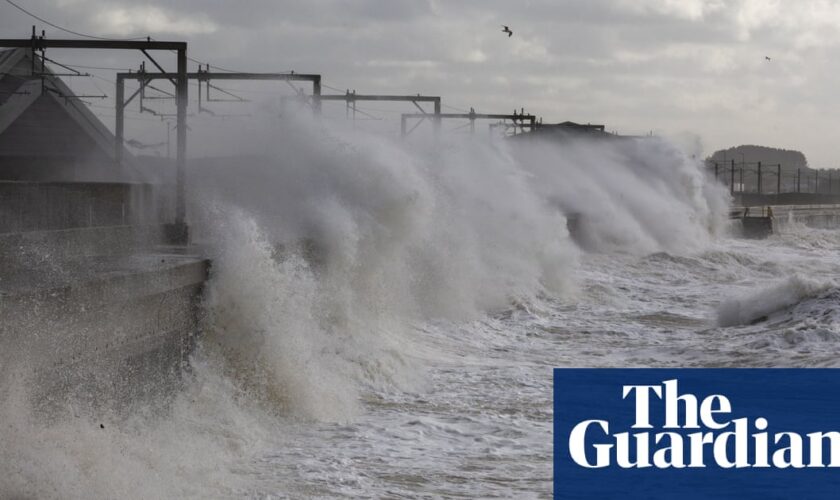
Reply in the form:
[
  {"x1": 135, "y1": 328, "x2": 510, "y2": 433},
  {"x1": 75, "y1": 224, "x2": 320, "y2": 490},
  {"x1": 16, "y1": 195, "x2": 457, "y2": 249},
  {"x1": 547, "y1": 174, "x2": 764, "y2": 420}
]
[{"x1": 0, "y1": 48, "x2": 133, "y2": 164}]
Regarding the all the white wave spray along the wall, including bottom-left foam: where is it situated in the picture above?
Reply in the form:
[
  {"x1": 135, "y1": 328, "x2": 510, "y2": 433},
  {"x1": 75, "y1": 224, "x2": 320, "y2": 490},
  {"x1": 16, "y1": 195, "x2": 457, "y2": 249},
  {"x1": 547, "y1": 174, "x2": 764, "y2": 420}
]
[{"x1": 0, "y1": 110, "x2": 726, "y2": 498}]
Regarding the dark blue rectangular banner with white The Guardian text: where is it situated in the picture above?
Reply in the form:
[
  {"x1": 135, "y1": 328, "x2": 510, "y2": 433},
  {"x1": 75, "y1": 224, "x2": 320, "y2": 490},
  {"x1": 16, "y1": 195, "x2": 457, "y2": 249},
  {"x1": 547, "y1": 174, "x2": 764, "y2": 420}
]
[{"x1": 554, "y1": 369, "x2": 840, "y2": 500}]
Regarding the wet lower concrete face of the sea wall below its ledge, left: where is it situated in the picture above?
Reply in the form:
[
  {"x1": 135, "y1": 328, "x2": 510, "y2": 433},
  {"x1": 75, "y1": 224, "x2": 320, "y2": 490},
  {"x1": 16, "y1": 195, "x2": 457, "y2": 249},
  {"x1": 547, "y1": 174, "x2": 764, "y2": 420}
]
[{"x1": 0, "y1": 254, "x2": 208, "y2": 414}]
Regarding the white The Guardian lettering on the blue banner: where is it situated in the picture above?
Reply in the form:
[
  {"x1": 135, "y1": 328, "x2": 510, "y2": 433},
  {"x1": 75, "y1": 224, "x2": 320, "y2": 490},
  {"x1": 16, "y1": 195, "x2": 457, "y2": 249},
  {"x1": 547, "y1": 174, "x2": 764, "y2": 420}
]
[{"x1": 568, "y1": 379, "x2": 840, "y2": 469}]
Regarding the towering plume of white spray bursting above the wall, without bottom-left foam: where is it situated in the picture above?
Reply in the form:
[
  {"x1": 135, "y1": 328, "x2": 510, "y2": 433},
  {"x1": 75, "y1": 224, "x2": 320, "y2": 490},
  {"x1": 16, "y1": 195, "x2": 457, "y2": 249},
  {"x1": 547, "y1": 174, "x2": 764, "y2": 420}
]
[{"x1": 185, "y1": 116, "x2": 727, "y2": 420}]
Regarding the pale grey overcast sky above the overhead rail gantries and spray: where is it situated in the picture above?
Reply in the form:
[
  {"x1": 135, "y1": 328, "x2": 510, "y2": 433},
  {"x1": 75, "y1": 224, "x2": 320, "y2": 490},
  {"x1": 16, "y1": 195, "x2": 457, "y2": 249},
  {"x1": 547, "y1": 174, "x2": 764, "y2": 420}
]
[{"x1": 0, "y1": 0, "x2": 840, "y2": 167}]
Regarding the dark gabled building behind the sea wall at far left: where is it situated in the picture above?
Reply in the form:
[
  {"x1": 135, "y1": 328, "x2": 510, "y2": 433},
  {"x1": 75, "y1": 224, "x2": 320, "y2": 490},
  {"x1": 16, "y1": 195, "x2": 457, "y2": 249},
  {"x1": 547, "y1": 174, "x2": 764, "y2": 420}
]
[{"x1": 0, "y1": 49, "x2": 139, "y2": 182}]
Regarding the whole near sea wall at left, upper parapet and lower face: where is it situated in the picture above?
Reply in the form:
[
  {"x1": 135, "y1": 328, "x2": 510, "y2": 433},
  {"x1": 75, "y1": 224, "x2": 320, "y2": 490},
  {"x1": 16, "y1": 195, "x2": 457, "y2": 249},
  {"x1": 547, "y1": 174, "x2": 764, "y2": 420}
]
[{"x1": 0, "y1": 182, "x2": 209, "y2": 414}]
